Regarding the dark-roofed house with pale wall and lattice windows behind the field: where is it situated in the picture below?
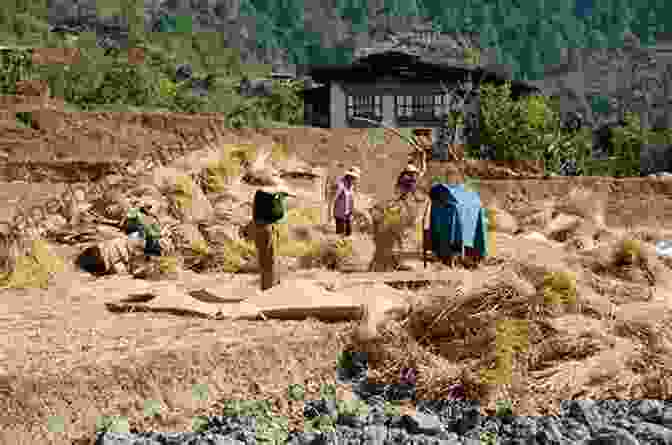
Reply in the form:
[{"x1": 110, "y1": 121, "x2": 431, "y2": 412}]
[{"x1": 304, "y1": 50, "x2": 539, "y2": 157}]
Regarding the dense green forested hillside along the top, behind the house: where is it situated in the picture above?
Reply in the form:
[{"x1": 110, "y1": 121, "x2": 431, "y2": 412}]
[{"x1": 0, "y1": 0, "x2": 672, "y2": 79}]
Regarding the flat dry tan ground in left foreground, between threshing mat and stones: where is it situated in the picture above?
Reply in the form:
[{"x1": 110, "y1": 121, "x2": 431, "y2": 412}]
[{"x1": 0, "y1": 268, "x2": 354, "y2": 444}]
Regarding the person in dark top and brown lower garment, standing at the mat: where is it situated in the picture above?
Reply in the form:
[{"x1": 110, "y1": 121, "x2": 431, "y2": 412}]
[{"x1": 252, "y1": 186, "x2": 292, "y2": 291}]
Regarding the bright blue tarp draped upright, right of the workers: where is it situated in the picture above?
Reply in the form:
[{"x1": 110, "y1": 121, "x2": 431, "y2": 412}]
[{"x1": 430, "y1": 184, "x2": 487, "y2": 257}]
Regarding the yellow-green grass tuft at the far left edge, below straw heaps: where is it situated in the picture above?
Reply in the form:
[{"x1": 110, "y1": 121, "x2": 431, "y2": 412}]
[{"x1": 0, "y1": 239, "x2": 65, "y2": 289}]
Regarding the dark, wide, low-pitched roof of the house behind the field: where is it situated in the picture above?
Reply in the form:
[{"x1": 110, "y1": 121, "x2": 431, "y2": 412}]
[{"x1": 308, "y1": 50, "x2": 538, "y2": 92}]
